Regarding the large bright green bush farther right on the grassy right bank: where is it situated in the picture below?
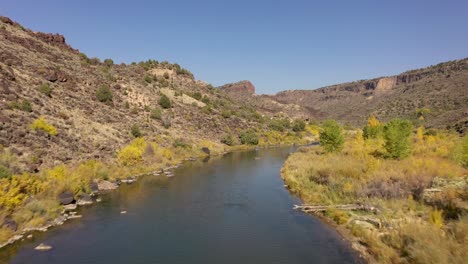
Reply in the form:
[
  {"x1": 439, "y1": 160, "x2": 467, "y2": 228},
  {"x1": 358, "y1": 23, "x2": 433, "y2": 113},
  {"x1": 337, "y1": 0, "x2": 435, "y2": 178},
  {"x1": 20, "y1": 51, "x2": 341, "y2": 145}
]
[{"x1": 384, "y1": 118, "x2": 413, "y2": 159}]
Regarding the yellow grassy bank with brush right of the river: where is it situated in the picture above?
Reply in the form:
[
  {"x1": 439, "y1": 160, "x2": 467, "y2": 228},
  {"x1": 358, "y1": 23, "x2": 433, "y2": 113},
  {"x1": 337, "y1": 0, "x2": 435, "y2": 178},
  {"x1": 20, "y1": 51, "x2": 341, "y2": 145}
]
[{"x1": 282, "y1": 122, "x2": 468, "y2": 263}]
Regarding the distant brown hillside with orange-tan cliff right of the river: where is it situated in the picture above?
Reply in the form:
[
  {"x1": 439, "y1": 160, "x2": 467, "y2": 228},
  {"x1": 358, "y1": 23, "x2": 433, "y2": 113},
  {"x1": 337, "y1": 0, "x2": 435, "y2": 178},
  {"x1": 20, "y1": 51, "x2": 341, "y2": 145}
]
[{"x1": 270, "y1": 59, "x2": 468, "y2": 133}]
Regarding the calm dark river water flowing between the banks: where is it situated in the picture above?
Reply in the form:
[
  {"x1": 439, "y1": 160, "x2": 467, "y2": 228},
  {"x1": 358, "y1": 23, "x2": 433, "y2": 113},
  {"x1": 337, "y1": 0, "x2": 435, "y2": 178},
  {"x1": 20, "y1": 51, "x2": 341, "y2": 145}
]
[{"x1": 0, "y1": 148, "x2": 360, "y2": 264}]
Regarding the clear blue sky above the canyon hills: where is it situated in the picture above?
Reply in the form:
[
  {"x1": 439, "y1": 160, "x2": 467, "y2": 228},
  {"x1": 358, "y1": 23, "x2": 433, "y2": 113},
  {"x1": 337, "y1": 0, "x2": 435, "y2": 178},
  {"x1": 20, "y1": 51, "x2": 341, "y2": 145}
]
[{"x1": 0, "y1": 0, "x2": 468, "y2": 93}]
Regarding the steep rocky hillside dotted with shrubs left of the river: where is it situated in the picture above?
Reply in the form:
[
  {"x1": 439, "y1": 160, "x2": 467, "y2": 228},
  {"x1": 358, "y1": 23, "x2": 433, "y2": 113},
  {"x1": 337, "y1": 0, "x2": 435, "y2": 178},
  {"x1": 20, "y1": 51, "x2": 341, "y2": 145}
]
[{"x1": 0, "y1": 17, "x2": 274, "y2": 173}]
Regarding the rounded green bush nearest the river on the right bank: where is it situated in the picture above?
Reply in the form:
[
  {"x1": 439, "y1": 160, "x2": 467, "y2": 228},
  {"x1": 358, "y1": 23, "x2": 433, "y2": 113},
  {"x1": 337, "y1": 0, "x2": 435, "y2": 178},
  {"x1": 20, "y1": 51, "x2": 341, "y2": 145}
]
[{"x1": 320, "y1": 120, "x2": 344, "y2": 152}]
